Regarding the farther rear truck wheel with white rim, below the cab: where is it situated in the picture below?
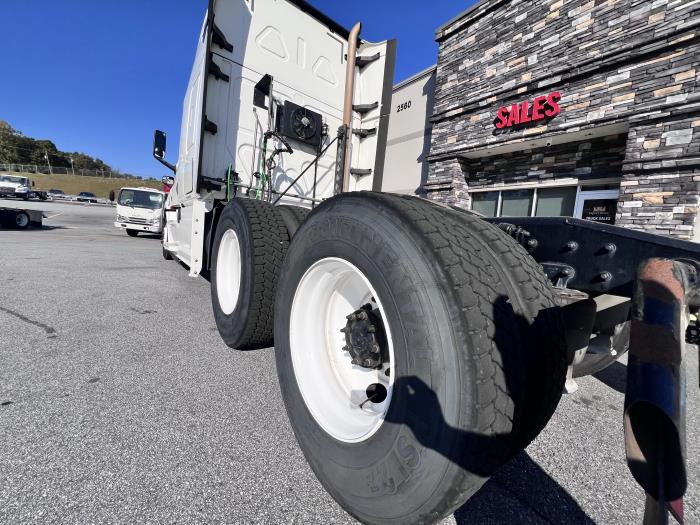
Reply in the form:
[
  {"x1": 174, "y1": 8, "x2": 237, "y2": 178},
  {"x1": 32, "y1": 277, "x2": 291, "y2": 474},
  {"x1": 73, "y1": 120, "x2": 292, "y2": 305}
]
[{"x1": 211, "y1": 199, "x2": 289, "y2": 350}]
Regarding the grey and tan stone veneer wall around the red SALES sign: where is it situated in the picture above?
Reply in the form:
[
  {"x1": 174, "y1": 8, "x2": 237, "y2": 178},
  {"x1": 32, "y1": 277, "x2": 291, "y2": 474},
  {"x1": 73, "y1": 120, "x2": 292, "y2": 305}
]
[{"x1": 425, "y1": 0, "x2": 700, "y2": 237}]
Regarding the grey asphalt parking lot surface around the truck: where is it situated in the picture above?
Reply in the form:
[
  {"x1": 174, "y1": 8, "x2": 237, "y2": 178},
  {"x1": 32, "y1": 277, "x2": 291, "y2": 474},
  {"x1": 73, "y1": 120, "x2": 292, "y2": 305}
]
[{"x1": 0, "y1": 201, "x2": 700, "y2": 524}]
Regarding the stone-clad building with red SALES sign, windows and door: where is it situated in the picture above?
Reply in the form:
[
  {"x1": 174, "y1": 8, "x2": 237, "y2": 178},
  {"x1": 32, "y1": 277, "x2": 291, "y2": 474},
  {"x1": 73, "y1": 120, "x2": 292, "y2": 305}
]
[{"x1": 423, "y1": 0, "x2": 700, "y2": 240}]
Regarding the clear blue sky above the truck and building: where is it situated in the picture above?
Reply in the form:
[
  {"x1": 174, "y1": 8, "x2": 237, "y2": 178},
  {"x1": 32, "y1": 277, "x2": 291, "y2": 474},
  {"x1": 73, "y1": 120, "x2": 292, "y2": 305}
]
[{"x1": 0, "y1": 0, "x2": 474, "y2": 178}]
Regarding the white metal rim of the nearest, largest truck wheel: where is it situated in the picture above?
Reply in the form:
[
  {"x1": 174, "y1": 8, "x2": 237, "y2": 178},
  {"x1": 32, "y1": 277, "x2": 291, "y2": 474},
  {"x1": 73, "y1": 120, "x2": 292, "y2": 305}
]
[{"x1": 289, "y1": 257, "x2": 394, "y2": 443}]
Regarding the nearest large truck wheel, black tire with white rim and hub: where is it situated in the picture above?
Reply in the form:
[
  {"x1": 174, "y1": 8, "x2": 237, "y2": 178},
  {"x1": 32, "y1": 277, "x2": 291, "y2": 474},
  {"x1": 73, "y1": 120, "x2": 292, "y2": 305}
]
[{"x1": 275, "y1": 192, "x2": 567, "y2": 524}]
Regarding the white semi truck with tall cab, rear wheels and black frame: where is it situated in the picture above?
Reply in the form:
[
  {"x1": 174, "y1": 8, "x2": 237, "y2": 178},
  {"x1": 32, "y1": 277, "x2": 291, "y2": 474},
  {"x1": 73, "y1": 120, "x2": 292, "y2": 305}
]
[{"x1": 153, "y1": 0, "x2": 700, "y2": 524}]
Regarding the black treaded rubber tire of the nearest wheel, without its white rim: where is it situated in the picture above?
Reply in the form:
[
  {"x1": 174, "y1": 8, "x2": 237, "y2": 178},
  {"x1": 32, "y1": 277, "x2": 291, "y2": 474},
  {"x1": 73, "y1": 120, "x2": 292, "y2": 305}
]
[{"x1": 275, "y1": 192, "x2": 567, "y2": 524}]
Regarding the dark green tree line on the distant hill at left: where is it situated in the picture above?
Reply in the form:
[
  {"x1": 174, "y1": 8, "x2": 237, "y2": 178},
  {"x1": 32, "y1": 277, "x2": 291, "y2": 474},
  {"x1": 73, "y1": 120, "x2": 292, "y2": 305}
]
[{"x1": 0, "y1": 120, "x2": 133, "y2": 177}]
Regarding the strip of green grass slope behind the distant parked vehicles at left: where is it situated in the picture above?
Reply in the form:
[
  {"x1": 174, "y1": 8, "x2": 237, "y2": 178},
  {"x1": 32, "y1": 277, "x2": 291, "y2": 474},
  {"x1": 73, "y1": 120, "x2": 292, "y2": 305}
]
[{"x1": 12, "y1": 173, "x2": 163, "y2": 199}]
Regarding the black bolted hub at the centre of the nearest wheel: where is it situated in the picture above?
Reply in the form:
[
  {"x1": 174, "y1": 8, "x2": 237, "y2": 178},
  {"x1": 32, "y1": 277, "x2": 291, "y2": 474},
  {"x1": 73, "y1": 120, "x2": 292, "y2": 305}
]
[{"x1": 340, "y1": 304, "x2": 386, "y2": 369}]
